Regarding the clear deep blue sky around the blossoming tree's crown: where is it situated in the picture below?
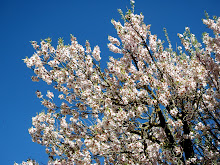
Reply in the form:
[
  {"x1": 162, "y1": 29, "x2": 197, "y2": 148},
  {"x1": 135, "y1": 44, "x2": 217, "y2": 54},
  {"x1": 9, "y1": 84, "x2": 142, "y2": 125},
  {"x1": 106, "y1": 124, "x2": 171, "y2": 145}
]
[{"x1": 0, "y1": 0, "x2": 220, "y2": 165}]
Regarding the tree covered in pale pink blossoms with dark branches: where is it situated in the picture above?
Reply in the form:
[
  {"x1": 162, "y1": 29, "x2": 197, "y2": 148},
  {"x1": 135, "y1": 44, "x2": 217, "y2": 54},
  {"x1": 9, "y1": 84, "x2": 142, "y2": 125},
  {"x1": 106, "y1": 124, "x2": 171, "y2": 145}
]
[{"x1": 19, "y1": 2, "x2": 220, "y2": 165}]
